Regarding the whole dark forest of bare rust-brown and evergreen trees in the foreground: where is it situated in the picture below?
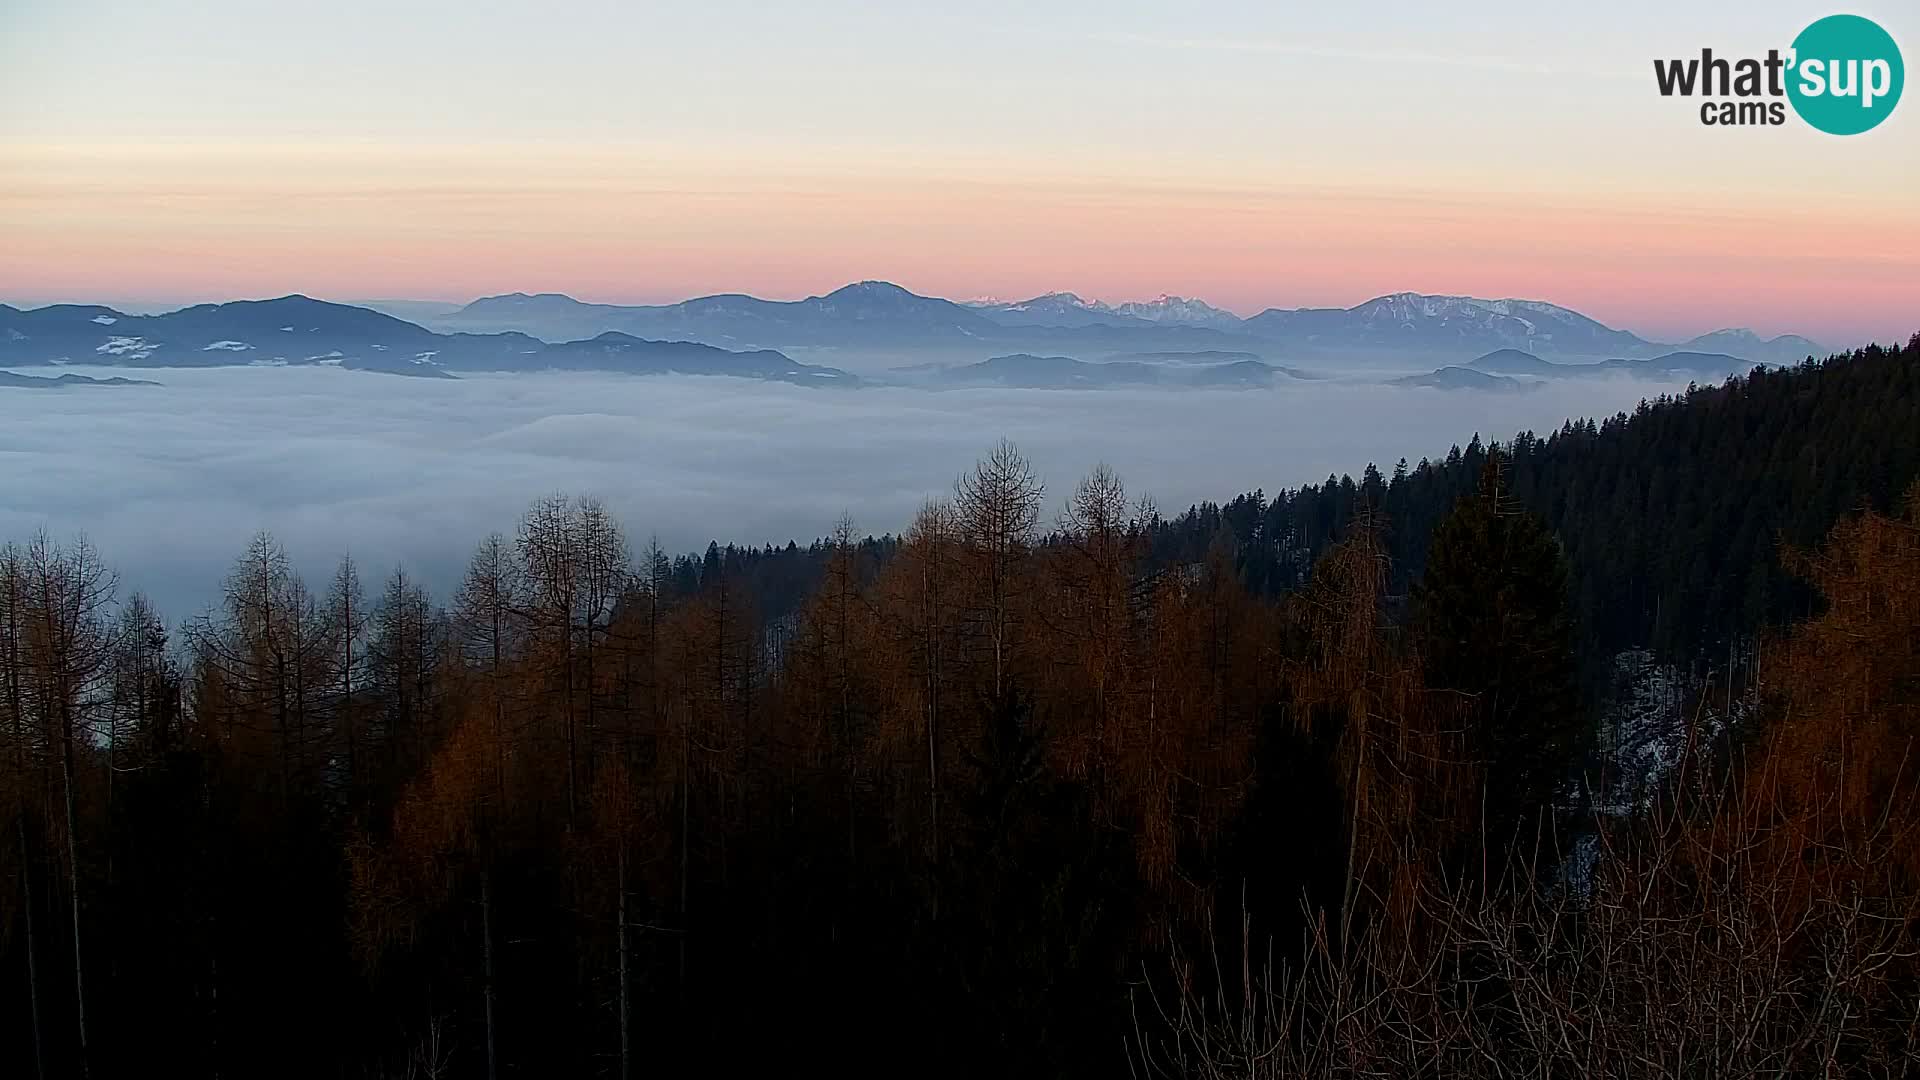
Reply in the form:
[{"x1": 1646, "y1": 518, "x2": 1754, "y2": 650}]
[{"x1": 0, "y1": 336, "x2": 1920, "y2": 1080}]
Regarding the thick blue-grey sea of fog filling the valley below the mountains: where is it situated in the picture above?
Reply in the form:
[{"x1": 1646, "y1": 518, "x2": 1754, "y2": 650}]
[{"x1": 0, "y1": 367, "x2": 1676, "y2": 619}]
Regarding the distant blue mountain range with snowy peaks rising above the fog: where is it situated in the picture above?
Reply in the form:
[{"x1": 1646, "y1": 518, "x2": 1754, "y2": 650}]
[{"x1": 0, "y1": 281, "x2": 1822, "y2": 386}]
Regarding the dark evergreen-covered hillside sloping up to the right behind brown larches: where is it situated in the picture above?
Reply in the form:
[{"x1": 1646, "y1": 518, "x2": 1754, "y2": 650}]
[{"x1": 1154, "y1": 334, "x2": 1920, "y2": 657}]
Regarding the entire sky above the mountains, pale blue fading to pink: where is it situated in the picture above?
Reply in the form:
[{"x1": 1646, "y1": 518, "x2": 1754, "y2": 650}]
[{"x1": 0, "y1": 0, "x2": 1920, "y2": 344}]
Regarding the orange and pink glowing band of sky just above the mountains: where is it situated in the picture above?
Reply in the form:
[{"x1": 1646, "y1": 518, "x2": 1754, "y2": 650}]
[{"x1": 0, "y1": 140, "x2": 1920, "y2": 344}]
